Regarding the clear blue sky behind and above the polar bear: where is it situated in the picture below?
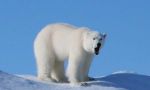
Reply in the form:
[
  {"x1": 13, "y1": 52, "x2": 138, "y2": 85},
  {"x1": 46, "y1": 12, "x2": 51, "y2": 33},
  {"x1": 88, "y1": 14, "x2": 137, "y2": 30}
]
[{"x1": 0, "y1": 0, "x2": 150, "y2": 76}]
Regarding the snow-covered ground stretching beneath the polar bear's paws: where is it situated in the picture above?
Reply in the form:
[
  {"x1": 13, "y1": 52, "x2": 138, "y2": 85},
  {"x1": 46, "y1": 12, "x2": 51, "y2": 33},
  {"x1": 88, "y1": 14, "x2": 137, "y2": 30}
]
[{"x1": 0, "y1": 71, "x2": 150, "y2": 90}]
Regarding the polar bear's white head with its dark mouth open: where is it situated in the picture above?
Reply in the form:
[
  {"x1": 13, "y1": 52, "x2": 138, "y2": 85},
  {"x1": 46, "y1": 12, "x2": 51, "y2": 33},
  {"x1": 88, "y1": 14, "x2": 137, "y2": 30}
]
[{"x1": 83, "y1": 31, "x2": 106, "y2": 55}]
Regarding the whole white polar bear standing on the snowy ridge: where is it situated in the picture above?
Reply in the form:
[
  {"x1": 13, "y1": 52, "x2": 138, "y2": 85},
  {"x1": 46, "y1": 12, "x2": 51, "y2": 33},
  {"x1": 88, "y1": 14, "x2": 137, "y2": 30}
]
[{"x1": 34, "y1": 23, "x2": 106, "y2": 84}]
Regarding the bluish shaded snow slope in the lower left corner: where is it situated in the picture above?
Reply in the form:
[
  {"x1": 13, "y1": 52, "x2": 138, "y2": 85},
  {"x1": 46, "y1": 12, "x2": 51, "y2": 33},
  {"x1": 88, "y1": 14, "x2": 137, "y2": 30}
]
[{"x1": 0, "y1": 71, "x2": 49, "y2": 90}]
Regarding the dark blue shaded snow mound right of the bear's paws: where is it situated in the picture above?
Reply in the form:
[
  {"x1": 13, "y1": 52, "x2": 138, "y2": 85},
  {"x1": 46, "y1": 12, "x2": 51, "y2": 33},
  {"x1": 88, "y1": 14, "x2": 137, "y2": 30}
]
[{"x1": 89, "y1": 73, "x2": 150, "y2": 90}]
